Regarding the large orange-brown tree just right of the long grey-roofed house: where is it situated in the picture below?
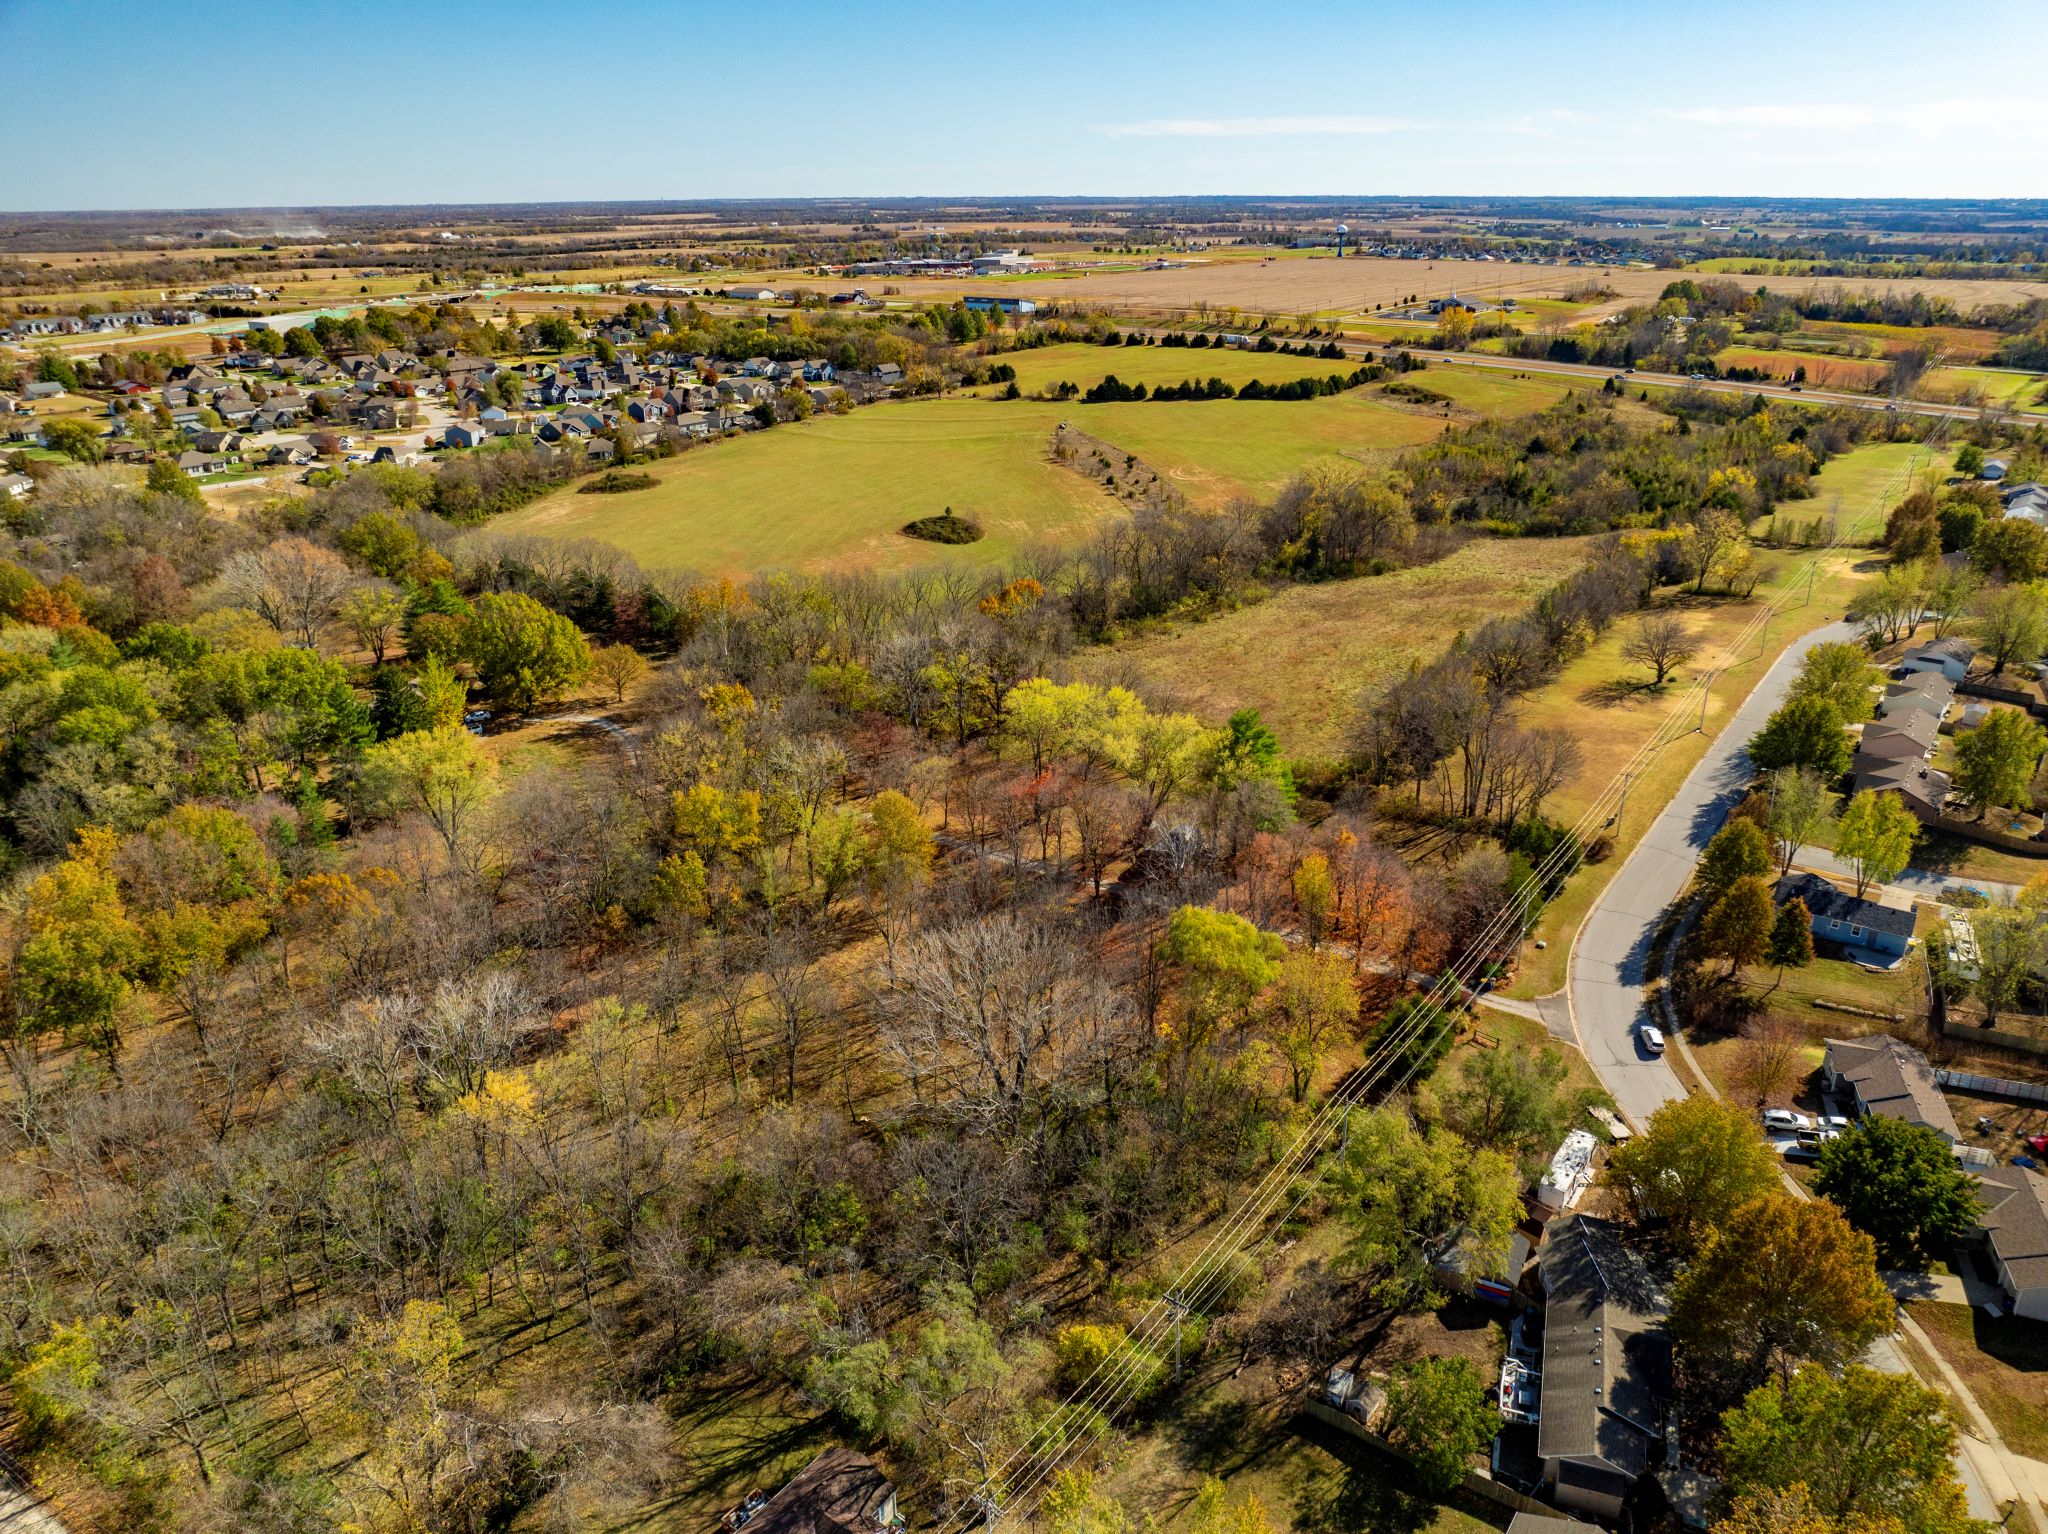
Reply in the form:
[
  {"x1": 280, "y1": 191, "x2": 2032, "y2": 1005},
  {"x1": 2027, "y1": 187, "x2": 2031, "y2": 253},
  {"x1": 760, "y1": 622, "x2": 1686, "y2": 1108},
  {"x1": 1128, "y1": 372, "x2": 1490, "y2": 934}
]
[{"x1": 1669, "y1": 1192, "x2": 1896, "y2": 1389}]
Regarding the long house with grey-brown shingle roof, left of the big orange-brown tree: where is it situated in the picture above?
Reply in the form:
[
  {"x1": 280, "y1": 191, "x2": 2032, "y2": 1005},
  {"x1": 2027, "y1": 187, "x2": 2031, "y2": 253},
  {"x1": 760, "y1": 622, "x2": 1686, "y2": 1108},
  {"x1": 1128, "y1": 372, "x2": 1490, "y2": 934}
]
[{"x1": 1536, "y1": 1215, "x2": 1671, "y2": 1520}]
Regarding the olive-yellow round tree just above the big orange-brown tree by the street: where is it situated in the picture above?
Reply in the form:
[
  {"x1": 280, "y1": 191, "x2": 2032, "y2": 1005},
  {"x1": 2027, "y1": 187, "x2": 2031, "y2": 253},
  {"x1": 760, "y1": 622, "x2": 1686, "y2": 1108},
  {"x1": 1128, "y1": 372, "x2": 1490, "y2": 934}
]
[{"x1": 1606, "y1": 1092, "x2": 1778, "y2": 1251}]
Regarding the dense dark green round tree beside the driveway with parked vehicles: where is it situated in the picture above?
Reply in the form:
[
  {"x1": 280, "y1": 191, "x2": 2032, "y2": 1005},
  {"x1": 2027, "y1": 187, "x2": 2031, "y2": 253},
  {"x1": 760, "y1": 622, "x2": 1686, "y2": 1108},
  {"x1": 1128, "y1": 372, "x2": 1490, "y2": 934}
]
[{"x1": 1812, "y1": 1114, "x2": 1978, "y2": 1268}]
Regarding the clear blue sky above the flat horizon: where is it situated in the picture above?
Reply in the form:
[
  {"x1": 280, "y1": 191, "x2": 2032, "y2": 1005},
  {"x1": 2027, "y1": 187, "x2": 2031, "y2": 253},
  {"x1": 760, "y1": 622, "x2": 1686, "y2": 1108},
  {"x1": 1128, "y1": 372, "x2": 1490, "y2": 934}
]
[{"x1": 0, "y1": 0, "x2": 2048, "y2": 211}]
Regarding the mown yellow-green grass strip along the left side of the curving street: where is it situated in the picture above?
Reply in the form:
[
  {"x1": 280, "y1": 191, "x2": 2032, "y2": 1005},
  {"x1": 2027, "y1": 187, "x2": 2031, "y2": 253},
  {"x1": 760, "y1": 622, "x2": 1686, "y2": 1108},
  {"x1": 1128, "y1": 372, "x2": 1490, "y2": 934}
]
[{"x1": 1509, "y1": 442, "x2": 1929, "y2": 995}]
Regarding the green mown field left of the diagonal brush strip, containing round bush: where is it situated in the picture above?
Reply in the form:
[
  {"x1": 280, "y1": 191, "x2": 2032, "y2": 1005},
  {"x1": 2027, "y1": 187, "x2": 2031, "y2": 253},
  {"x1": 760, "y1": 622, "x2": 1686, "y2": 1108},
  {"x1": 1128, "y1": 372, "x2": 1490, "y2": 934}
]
[{"x1": 498, "y1": 399, "x2": 1114, "y2": 576}]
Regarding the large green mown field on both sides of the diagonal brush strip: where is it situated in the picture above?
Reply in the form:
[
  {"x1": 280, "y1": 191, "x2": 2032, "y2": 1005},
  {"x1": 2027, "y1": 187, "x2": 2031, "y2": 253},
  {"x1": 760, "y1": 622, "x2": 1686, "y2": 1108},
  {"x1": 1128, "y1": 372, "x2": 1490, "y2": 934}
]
[{"x1": 496, "y1": 378, "x2": 1561, "y2": 576}]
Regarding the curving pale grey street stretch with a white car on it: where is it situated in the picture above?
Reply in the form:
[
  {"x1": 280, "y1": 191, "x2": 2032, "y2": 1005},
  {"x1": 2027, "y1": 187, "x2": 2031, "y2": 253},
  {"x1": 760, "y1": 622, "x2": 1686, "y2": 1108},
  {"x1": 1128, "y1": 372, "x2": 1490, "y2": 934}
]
[{"x1": 1569, "y1": 623, "x2": 1855, "y2": 1126}]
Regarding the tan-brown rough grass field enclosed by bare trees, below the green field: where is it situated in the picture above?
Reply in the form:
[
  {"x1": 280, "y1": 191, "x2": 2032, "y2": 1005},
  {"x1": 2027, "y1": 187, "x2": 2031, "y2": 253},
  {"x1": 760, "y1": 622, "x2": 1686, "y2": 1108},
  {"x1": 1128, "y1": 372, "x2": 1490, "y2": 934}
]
[{"x1": 1077, "y1": 536, "x2": 1591, "y2": 758}]
